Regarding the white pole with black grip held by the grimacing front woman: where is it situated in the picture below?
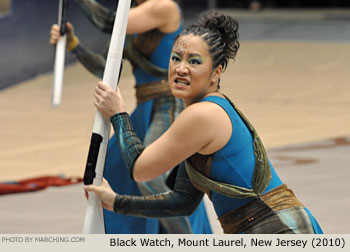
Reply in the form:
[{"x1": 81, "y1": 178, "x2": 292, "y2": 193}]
[{"x1": 83, "y1": 0, "x2": 131, "y2": 234}]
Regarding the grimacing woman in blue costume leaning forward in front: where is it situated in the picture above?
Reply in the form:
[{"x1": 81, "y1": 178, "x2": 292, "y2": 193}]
[{"x1": 86, "y1": 9, "x2": 322, "y2": 233}]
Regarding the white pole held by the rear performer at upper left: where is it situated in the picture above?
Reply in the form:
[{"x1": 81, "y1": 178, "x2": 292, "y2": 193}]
[{"x1": 51, "y1": 0, "x2": 68, "y2": 106}]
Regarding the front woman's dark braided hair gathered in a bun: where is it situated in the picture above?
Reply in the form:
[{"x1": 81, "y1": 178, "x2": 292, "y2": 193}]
[{"x1": 180, "y1": 11, "x2": 239, "y2": 70}]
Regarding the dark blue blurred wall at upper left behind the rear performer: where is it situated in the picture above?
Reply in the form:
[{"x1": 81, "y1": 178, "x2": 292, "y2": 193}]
[{"x1": 0, "y1": 0, "x2": 117, "y2": 90}]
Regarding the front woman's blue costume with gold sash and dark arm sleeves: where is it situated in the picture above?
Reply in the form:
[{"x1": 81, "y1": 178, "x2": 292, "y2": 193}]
[{"x1": 111, "y1": 96, "x2": 322, "y2": 234}]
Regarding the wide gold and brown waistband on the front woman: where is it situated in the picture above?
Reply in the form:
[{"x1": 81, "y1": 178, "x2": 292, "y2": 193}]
[{"x1": 218, "y1": 185, "x2": 303, "y2": 234}]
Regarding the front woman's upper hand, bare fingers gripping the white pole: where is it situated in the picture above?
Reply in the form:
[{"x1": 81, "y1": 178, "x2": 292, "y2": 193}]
[{"x1": 94, "y1": 81, "x2": 125, "y2": 119}]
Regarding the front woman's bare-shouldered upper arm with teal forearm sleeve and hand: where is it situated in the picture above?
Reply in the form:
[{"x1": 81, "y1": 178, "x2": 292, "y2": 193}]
[{"x1": 94, "y1": 82, "x2": 228, "y2": 181}]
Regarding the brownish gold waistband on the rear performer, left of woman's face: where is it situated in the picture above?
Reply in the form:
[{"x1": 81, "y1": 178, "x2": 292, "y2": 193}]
[{"x1": 135, "y1": 82, "x2": 173, "y2": 103}]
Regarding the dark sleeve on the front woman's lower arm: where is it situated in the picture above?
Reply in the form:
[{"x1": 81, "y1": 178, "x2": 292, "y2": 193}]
[{"x1": 113, "y1": 163, "x2": 204, "y2": 218}]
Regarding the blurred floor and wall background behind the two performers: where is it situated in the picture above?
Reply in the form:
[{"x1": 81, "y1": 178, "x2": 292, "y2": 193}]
[{"x1": 0, "y1": 0, "x2": 350, "y2": 233}]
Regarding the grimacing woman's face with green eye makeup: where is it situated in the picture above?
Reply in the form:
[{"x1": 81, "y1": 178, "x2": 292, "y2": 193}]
[{"x1": 169, "y1": 34, "x2": 217, "y2": 105}]
